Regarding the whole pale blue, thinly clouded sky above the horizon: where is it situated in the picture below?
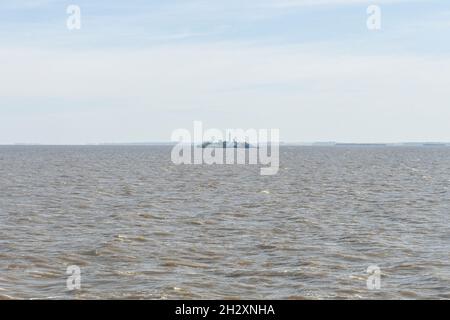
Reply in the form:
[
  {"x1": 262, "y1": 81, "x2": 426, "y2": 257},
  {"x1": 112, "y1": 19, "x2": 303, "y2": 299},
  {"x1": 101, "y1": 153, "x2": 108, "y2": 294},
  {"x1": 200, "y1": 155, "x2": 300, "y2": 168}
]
[{"x1": 0, "y1": 0, "x2": 450, "y2": 144}]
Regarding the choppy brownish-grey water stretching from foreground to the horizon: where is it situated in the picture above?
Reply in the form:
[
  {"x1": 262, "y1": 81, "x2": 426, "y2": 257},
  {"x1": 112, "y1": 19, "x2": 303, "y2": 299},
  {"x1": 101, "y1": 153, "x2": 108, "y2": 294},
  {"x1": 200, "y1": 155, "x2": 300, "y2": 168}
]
[{"x1": 0, "y1": 146, "x2": 450, "y2": 299}]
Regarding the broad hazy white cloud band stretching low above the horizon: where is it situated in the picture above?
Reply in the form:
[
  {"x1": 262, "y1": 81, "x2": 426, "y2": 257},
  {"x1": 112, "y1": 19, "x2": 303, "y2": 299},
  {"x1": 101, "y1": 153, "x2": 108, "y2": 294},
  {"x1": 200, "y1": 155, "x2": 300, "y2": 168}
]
[{"x1": 0, "y1": 44, "x2": 450, "y2": 143}]
